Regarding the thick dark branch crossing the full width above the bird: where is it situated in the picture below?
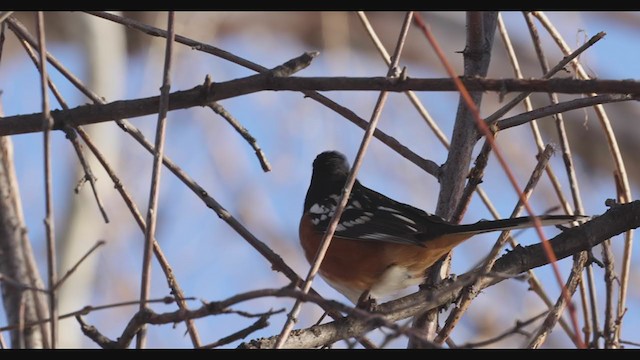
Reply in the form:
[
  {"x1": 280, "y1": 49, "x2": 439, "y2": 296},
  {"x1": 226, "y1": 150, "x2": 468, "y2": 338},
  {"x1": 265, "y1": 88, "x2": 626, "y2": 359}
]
[{"x1": 0, "y1": 77, "x2": 640, "y2": 136}]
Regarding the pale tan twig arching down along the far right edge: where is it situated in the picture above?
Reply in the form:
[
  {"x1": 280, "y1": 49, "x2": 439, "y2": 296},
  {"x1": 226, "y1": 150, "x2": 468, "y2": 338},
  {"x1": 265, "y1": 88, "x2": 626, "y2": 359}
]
[{"x1": 532, "y1": 11, "x2": 633, "y2": 342}]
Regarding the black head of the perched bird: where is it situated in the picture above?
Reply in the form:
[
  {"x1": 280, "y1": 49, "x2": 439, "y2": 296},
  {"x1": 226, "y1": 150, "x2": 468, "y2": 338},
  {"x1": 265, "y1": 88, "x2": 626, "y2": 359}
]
[{"x1": 304, "y1": 151, "x2": 351, "y2": 211}]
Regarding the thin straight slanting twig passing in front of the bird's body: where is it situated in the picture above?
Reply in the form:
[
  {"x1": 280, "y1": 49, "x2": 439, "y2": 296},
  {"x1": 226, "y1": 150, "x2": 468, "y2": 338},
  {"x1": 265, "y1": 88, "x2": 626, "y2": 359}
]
[{"x1": 274, "y1": 11, "x2": 413, "y2": 349}]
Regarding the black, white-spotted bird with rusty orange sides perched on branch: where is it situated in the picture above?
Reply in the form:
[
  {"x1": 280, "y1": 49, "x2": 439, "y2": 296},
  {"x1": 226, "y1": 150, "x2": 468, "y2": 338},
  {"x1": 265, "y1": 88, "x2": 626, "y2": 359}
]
[{"x1": 299, "y1": 151, "x2": 576, "y2": 304}]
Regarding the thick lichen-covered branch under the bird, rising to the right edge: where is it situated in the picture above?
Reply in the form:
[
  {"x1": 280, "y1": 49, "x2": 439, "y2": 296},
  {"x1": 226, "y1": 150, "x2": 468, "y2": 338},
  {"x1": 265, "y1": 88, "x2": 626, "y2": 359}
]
[{"x1": 241, "y1": 200, "x2": 640, "y2": 348}]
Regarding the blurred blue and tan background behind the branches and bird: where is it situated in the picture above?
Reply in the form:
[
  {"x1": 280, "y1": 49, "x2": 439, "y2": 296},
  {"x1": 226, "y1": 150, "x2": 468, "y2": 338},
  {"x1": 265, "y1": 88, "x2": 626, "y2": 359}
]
[{"x1": 0, "y1": 12, "x2": 640, "y2": 348}]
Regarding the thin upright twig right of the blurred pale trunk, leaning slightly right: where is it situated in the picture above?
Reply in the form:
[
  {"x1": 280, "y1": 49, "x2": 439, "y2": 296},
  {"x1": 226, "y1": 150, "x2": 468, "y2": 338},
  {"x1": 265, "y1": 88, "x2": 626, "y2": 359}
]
[{"x1": 136, "y1": 11, "x2": 175, "y2": 349}]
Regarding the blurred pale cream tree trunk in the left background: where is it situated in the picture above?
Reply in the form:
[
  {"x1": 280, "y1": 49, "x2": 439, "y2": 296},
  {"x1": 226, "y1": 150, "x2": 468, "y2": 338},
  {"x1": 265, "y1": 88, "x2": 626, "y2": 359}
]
[{"x1": 59, "y1": 13, "x2": 127, "y2": 348}]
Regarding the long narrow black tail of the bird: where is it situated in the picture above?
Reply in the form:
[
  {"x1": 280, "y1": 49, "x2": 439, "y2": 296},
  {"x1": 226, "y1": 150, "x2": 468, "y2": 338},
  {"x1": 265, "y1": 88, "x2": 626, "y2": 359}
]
[{"x1": 456, "y1": 215, "x2": 588, "y2": 234}]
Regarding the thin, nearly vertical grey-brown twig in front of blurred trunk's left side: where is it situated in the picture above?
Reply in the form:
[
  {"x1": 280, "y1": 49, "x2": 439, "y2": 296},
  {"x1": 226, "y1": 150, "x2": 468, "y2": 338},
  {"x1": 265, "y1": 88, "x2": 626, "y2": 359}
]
[{"x1": 36, "y1": 11, "x2": 58, "y2": 349}]
